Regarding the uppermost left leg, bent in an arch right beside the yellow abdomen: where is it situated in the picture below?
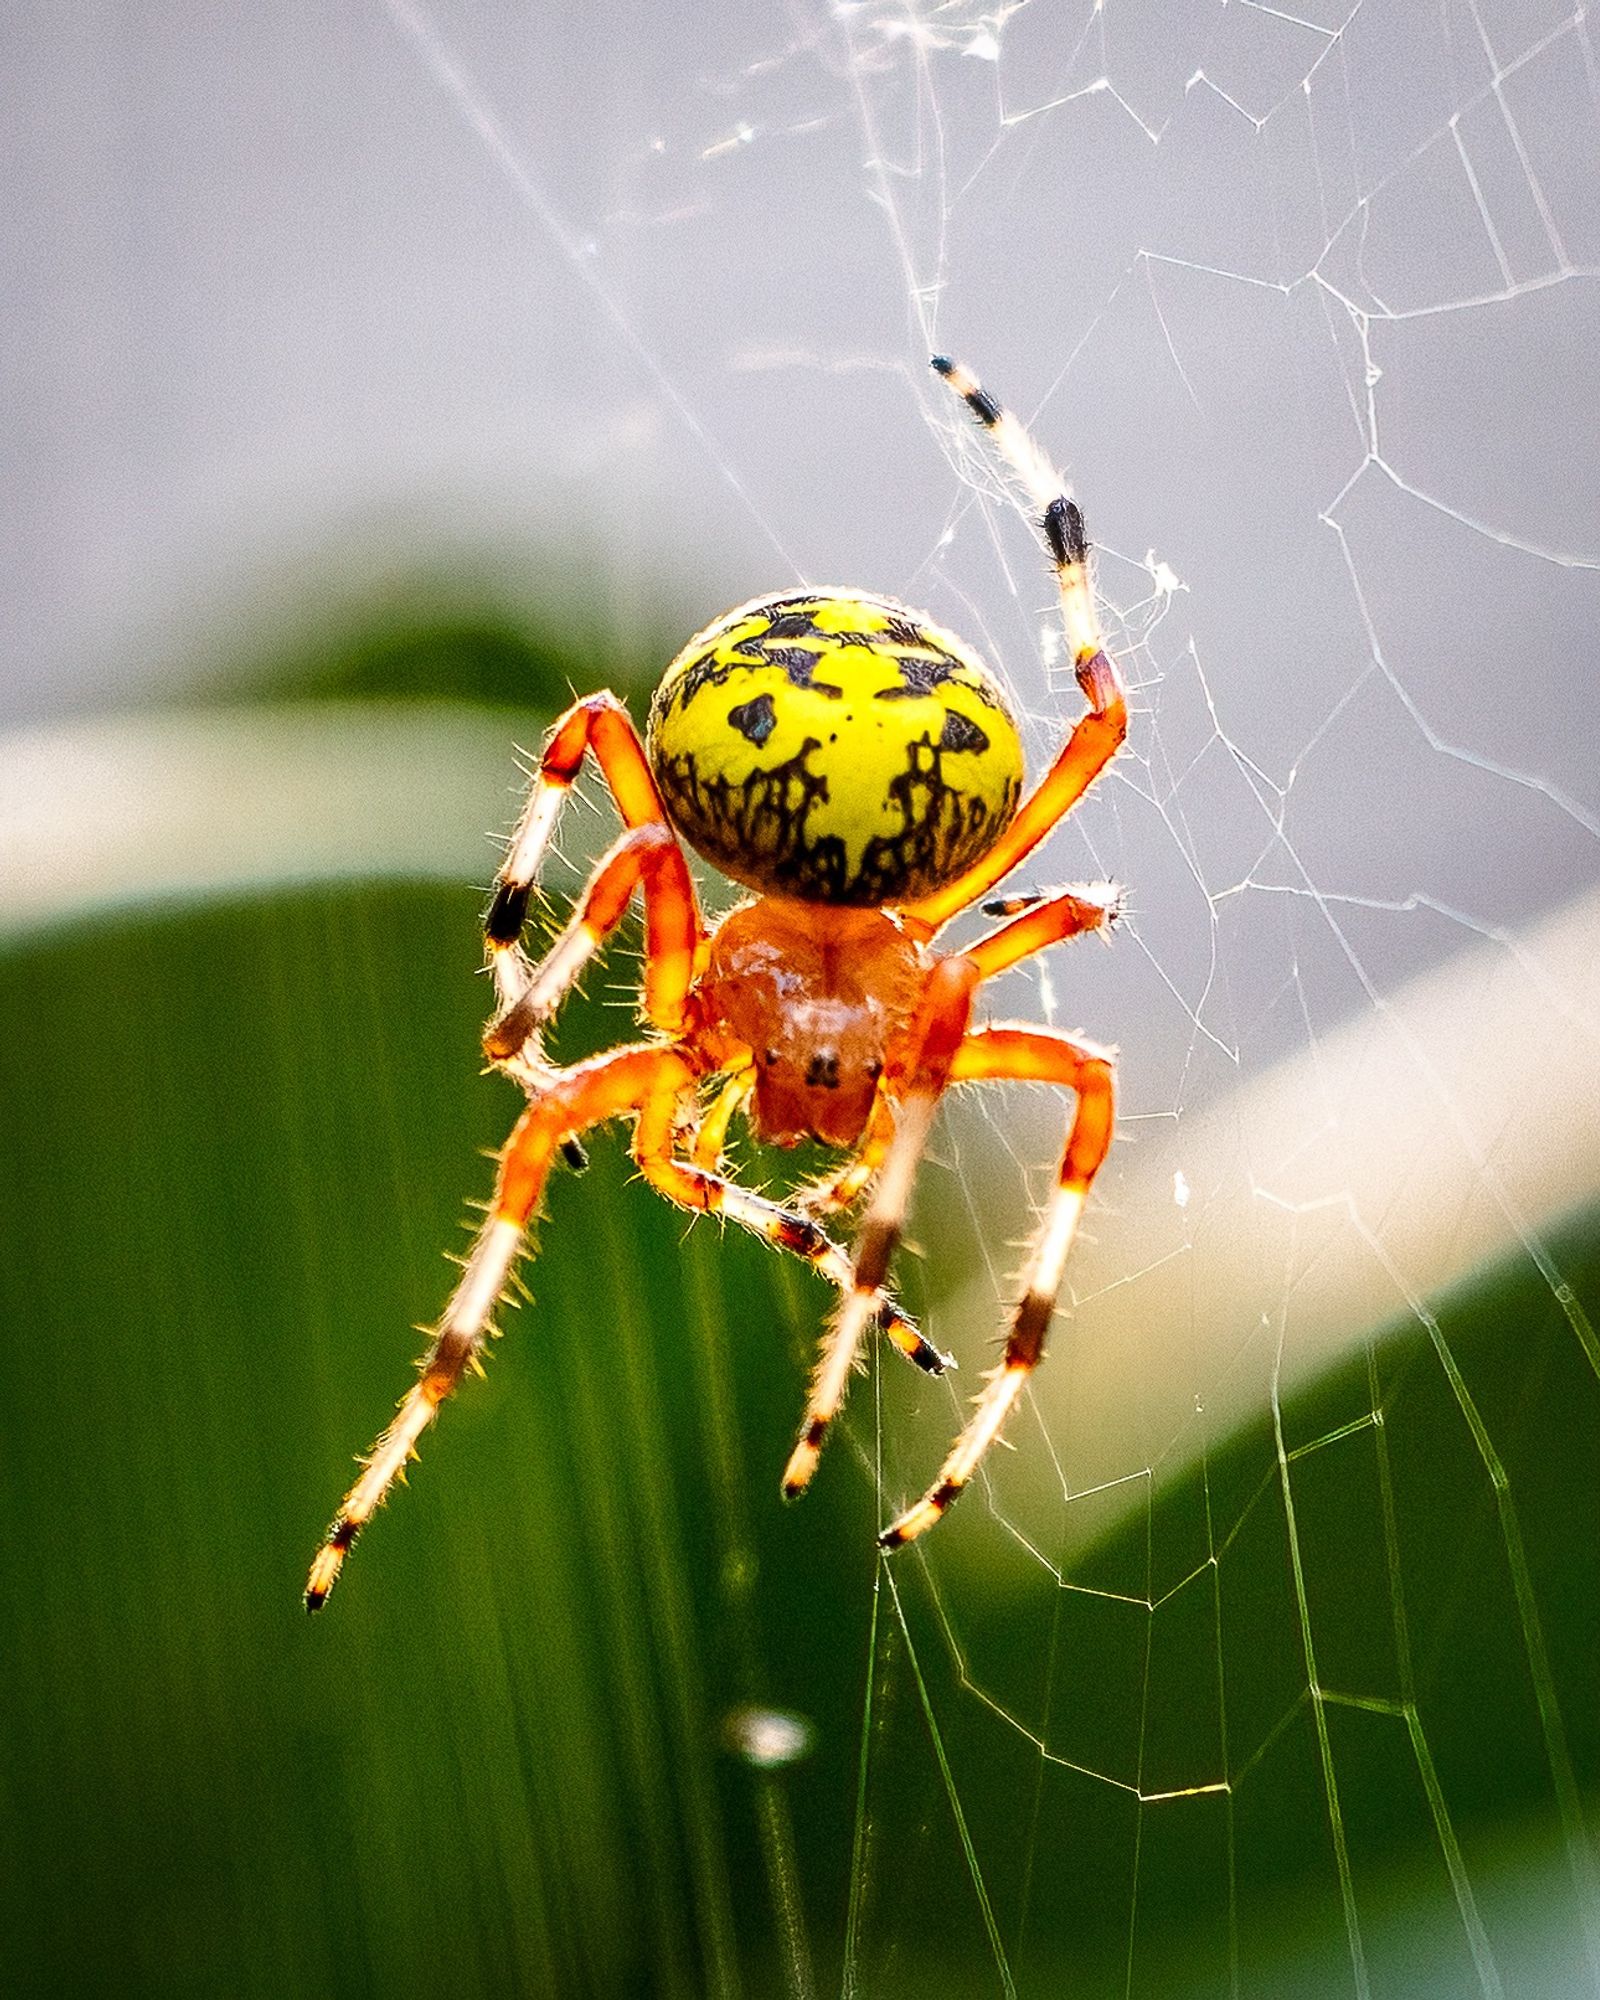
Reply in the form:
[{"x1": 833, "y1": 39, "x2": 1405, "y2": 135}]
[{"x1": 484, "y1": 690, "x2": 702, "y2": 1034}]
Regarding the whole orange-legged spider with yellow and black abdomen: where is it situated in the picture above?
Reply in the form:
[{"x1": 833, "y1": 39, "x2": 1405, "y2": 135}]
[{"x1": 306, "y1": 356, "x2": 1128, "y2": 1610}]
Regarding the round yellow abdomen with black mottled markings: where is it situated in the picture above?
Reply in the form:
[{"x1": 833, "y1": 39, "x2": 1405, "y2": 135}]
[{"x1": 648, "y1": 590, "x2": 1022, "y2": 904}]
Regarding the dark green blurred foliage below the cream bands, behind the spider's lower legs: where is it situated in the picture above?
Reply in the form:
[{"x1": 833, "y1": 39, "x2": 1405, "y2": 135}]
[{"x1": 0, "y1": 886, "x2": 1600, "y2": 2000}]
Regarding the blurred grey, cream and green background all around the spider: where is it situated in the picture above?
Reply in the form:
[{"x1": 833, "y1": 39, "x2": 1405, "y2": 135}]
[{"x1": 0, "y1": 0, "x2": 1600, "y2": 2000}]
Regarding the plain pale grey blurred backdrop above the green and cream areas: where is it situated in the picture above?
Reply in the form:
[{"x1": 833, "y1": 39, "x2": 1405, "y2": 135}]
[{"x1": 0, "y1": 0, "x2": 1600, "y2": 1116}]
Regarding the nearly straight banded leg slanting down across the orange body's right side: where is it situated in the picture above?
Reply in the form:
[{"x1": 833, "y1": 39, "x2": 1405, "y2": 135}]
[{"x1": 784, "y1": 956, "x2": 980, "y2": 1500}]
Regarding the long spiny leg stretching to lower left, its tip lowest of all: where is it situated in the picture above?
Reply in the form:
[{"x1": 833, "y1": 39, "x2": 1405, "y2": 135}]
[{"x1": 306, "y1": 1046, "x2": 694, "y2": 1612}]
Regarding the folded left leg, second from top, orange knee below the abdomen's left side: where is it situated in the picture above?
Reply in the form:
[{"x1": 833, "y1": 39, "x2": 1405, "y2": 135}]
[{"x1": 484, "y1": 822, "x2": 700, "y2": 1062}]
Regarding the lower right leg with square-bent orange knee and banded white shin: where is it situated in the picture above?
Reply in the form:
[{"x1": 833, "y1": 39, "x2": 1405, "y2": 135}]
[{"x1": 878, "y1": 1028, "x2": 1116, "y2": 1548}]
